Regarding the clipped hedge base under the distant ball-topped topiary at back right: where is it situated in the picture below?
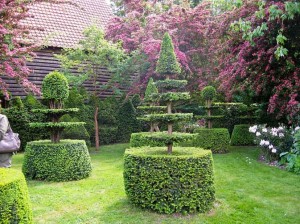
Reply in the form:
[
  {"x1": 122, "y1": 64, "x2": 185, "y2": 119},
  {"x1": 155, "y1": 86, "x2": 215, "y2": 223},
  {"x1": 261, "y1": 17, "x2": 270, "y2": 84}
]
[{"x1": 192, "y1": 128, "x2": 230, "y2": 153}]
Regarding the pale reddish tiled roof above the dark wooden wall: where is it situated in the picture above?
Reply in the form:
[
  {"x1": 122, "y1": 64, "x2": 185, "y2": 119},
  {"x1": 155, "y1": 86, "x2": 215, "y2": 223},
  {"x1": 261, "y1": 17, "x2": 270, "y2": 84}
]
[{"x1": 22, "y1": 0, "x2": 113, "y2": 48}]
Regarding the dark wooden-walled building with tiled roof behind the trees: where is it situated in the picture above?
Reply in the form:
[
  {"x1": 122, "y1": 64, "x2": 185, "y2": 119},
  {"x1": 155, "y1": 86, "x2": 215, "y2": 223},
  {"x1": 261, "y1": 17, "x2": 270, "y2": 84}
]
[{"x1": 4, "y1": 0, "x2": 113, "y2": 98}]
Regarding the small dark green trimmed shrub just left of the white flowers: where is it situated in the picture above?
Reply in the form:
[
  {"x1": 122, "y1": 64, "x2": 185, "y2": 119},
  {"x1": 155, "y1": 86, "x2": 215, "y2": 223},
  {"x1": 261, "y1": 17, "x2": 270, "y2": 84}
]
[{"x1": 230, "y1": 124, "x2": 254, "y2": 145}]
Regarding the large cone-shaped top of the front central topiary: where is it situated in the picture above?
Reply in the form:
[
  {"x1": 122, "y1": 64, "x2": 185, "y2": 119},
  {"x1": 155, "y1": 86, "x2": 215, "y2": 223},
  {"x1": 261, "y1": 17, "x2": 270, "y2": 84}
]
[{"x1": 156, "y1": 33, "x2": 181, "y2": 75}]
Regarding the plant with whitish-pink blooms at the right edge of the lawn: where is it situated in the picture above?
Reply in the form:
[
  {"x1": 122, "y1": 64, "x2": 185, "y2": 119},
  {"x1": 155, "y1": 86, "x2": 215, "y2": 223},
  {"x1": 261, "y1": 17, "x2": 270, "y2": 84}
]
[{"x1": 249, "y1": 125, "x2": 293, "y2": 162}]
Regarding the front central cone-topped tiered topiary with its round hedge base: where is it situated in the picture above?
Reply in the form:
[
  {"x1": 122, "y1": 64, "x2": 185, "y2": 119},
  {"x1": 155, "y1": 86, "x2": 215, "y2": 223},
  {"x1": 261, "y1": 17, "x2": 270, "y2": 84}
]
[{"x1": 124, "y1": 34, "x2": 215, "y2": 214}]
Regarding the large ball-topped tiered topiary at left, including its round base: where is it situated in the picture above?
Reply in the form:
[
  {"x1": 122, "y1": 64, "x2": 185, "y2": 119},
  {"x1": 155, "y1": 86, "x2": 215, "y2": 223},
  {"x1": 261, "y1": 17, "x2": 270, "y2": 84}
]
[{"x1": 23, "y1": 72, "x2": 91, "y2": 181}]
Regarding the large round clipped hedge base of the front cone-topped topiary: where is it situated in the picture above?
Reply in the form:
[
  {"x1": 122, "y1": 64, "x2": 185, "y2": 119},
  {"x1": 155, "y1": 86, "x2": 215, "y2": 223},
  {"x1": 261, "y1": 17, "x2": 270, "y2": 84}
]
[{"x1": 124, "y1": 146, "x2": 215, "y2": 214}]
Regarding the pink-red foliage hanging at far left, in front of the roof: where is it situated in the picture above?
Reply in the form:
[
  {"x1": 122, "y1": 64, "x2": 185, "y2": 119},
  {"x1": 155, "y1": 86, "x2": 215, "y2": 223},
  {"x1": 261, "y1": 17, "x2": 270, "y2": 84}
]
[{"x1": 0, "y1": 0, "x2": 65, "y2": 98}]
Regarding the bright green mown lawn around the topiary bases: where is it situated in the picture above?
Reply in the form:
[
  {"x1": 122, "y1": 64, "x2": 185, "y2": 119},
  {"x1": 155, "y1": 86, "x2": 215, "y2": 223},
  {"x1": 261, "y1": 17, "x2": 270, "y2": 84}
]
[{"x1": 13, "y1": 144, "x2": 300, "y2": 224}]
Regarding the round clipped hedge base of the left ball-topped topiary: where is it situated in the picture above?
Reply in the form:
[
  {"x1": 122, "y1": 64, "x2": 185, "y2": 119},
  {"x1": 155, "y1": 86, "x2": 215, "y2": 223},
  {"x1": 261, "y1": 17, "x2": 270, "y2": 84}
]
[{"x1": 22, "y1": 139, "x2": 92, "y2": 181}]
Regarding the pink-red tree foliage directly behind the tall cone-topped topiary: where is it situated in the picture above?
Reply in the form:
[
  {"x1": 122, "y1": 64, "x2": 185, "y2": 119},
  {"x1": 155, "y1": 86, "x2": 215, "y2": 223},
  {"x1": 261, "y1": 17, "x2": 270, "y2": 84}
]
[{"x1": 106, "y1": 0, "x2": 211, "y2": 92}]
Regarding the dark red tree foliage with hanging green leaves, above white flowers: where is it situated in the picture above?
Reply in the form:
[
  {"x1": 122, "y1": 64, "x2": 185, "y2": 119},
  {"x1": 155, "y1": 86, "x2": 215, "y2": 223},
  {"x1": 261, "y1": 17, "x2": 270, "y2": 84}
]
[{"x1": 210, "y1": 0, "x2": 300, "y2": 121}]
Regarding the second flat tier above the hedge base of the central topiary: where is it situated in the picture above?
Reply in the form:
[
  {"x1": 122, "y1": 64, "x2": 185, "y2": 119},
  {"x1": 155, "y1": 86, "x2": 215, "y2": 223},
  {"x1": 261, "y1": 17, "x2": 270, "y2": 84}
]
[{"x1": 145, "y1": 113, "x2": 193, "y2": 123}]
